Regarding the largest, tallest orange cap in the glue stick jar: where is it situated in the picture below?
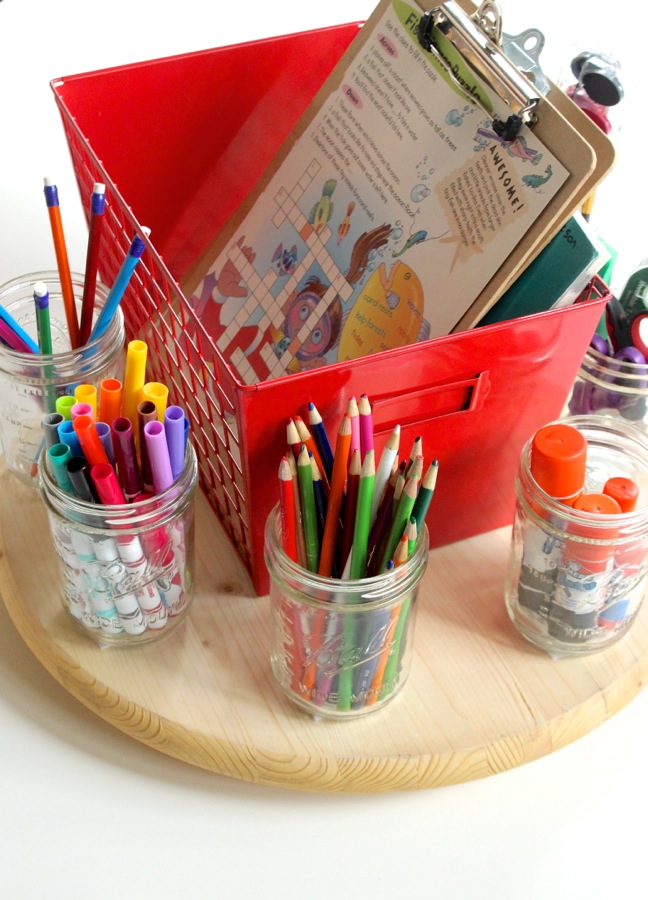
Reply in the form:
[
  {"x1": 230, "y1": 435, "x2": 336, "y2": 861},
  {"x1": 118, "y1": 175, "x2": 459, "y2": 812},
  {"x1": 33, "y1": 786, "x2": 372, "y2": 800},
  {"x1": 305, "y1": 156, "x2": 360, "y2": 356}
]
[{"x1": 531, "y1": 422, "x2": 587, "y2": 503}]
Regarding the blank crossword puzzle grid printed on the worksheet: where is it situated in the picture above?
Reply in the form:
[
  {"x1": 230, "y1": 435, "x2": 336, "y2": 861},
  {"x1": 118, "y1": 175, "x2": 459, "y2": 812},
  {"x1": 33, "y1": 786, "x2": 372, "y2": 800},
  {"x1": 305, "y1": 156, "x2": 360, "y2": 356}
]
[{"x1": 217, "y1": 160, "x2": 353, "y2": 384}]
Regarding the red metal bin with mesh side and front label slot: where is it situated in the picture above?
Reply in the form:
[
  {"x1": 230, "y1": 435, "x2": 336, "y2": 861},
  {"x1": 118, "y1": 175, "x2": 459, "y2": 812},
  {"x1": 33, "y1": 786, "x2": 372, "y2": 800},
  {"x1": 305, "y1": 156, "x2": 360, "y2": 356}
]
[{"x1": 52, "y1": 24, "x2": 605, "y2": 594}]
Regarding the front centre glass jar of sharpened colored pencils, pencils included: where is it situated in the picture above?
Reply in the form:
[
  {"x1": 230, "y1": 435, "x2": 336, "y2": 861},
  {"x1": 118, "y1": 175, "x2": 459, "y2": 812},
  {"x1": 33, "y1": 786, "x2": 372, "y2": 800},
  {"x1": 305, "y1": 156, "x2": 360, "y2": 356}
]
[{"x1": 265, "y1": 394, "x2": 438, "y2": 719}]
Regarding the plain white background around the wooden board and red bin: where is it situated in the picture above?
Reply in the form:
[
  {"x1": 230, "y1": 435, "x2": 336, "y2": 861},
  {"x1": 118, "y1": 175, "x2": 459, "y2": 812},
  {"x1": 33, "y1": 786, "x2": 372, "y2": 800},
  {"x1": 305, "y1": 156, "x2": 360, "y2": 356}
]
[{"x1": 0, "y1": 0, "x2": 648, "y2": 900}]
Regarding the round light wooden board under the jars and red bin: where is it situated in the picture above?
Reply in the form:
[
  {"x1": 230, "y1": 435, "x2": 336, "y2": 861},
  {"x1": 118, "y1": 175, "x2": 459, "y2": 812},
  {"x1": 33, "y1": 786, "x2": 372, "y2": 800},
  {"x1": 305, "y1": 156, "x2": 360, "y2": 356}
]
[{"x1": 0, "y1": 469, "x2": 648, "y2": 793}]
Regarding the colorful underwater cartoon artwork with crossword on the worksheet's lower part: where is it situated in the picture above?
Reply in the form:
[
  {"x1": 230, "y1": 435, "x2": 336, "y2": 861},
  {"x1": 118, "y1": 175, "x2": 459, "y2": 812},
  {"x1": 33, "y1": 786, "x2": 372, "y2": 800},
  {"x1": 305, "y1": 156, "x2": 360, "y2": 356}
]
[{"x1": 192, "y1": 161, "x2": 438, "y2": 383}]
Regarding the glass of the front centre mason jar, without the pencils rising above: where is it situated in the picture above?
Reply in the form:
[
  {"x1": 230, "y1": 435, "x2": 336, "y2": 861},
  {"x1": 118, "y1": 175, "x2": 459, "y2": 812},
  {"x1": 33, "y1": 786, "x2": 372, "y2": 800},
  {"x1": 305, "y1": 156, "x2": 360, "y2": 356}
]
[{"x1": 265, "y1": 509, "x2": 428, "y2": 719}]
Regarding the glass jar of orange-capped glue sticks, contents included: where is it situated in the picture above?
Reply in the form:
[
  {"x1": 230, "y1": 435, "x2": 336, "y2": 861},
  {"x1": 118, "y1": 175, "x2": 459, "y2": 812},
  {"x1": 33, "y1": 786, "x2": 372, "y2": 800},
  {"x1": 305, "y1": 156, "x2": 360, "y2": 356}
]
[{"x1": 505, "y1": 416, "x2": 648, "y2": 656}]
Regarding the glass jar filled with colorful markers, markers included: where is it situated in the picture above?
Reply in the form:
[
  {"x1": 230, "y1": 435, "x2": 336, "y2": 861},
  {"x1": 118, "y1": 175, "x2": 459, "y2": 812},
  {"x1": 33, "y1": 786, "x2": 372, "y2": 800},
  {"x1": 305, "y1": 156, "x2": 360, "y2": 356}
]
[{"x1": 39, "y1": 341, "x2": 197, "y2": 647}]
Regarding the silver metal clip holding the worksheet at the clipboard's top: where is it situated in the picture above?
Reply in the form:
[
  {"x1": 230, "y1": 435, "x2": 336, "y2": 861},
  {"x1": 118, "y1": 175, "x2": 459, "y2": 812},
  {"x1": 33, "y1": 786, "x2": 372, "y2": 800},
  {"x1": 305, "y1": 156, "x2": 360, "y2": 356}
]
[{"x1": 418, "y1": 0, "x2": 540, "y2": 141}]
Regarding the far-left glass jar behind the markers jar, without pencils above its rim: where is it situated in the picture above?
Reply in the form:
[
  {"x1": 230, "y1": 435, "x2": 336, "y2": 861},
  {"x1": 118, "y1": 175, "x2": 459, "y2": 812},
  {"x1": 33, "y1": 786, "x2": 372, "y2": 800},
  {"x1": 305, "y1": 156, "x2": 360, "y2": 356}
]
[{"x1": 0, "y1": 271, "x2": 125, "y2": 486}]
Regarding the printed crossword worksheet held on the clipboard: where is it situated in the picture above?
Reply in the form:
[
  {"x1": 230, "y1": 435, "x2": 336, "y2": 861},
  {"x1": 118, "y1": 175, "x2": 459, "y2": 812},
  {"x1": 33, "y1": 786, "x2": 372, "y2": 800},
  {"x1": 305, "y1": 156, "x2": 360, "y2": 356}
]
[{"x1": 190, "y1": 0, "x2": 568, "y2": 384}]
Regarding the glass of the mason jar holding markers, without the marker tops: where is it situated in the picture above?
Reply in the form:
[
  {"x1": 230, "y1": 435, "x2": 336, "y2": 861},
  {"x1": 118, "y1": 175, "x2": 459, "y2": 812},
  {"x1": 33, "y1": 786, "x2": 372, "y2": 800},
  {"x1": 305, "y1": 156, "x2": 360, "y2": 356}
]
[{"x1": 39, "y1": 444, "x2": 197, "y2": 647}]
